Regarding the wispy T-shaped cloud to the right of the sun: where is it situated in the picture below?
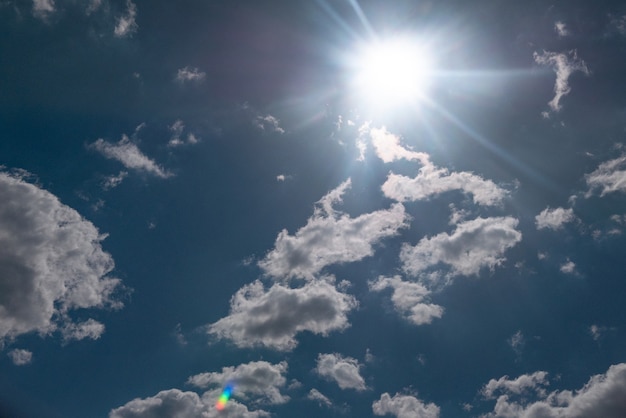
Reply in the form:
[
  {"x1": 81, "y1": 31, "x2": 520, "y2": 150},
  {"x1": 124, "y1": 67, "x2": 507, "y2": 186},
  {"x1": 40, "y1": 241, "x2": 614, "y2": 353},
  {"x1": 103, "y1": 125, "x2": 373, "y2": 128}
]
[{"x1": 533, "y1": 50, "x2": 590, "y2": 112}]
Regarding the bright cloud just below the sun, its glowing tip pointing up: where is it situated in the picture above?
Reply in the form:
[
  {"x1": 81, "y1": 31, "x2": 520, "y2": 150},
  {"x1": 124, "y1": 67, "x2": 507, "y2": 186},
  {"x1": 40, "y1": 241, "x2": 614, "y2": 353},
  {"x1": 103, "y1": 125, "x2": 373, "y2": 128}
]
[{"x1": 372, "y1": 140, "x2": 507, "y2": 206}]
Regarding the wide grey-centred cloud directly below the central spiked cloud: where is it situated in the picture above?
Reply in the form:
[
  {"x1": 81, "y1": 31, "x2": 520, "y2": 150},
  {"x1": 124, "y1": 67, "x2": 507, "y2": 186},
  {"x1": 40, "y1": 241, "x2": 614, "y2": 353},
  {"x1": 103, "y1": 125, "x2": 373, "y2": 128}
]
[{"x1": 208, "y1": 280, "x2": 357, "y2": 351}]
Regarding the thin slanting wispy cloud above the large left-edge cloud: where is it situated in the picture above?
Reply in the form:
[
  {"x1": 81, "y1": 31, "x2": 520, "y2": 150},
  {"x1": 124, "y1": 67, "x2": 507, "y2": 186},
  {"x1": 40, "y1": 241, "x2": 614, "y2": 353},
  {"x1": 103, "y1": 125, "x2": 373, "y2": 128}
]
[{"x1": 89, "y1": 135, "x2": 172, "y2": 178}]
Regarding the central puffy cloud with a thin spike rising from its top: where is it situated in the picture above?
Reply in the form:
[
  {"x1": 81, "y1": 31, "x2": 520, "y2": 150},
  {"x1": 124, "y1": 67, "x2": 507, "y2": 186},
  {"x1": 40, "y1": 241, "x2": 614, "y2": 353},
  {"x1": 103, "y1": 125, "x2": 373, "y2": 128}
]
[{"x1": 259, "y1": 179, "x2": 408, "y2": 279}]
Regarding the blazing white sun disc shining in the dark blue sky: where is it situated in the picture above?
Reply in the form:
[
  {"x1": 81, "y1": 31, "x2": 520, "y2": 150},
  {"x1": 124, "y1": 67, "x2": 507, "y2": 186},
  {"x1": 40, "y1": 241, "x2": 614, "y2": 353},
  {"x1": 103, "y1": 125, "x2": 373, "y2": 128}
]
[{"x1": 354, "y1": 38, "x2": 434, "y2": 108}]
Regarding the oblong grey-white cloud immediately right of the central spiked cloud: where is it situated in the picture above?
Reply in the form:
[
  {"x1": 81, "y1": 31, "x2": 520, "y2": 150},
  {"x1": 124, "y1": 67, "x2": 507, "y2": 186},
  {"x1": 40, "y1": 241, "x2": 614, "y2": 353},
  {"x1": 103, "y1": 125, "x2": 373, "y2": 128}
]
[{"x1": 400, "y1": 217, "x2": 522, "y2": 276}]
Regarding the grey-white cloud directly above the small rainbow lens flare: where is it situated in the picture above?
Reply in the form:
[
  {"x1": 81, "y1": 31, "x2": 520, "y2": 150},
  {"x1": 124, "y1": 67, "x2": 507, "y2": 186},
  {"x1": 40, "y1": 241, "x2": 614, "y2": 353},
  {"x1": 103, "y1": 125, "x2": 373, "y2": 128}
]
[{"x1": 187, "y1": 361, "x2": 289, "y2": 404}]
